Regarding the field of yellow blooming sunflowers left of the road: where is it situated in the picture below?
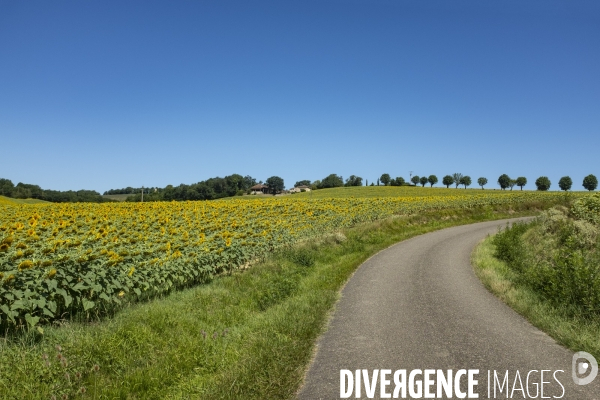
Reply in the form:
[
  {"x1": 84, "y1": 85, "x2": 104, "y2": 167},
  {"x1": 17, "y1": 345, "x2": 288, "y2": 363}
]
[{"x1": 0, "y1": 192, "x2": 563, "y2": 331}]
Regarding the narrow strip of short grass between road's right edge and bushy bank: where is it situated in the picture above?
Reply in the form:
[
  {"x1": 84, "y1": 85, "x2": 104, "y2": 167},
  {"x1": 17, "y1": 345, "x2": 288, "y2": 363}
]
[{"x1": 472, "y1": 237, "x2": 600, "y2": 358}]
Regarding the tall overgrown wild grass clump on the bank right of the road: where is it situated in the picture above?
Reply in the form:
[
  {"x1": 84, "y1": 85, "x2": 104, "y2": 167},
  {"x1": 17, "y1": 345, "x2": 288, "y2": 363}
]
[{"x1": 493, "y1": 195, "x2": 600, "y2": 318}]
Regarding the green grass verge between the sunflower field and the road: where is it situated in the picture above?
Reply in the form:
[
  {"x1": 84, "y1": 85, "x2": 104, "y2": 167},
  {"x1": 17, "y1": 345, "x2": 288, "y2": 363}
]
[{"x1": 0, "y1": 202, "x2": 552, "y2": 399}]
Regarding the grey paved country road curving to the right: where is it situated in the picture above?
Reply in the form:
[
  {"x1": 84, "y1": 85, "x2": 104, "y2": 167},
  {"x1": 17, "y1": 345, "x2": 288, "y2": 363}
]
[{"x1": 298, "y1": 220, "x2": 600, "y2": 400}]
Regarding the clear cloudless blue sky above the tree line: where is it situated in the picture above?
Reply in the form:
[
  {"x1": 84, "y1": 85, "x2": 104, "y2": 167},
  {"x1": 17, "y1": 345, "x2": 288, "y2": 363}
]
[{"x1": 0, "y1": 0, "x2": 600, "y2": 192}]
